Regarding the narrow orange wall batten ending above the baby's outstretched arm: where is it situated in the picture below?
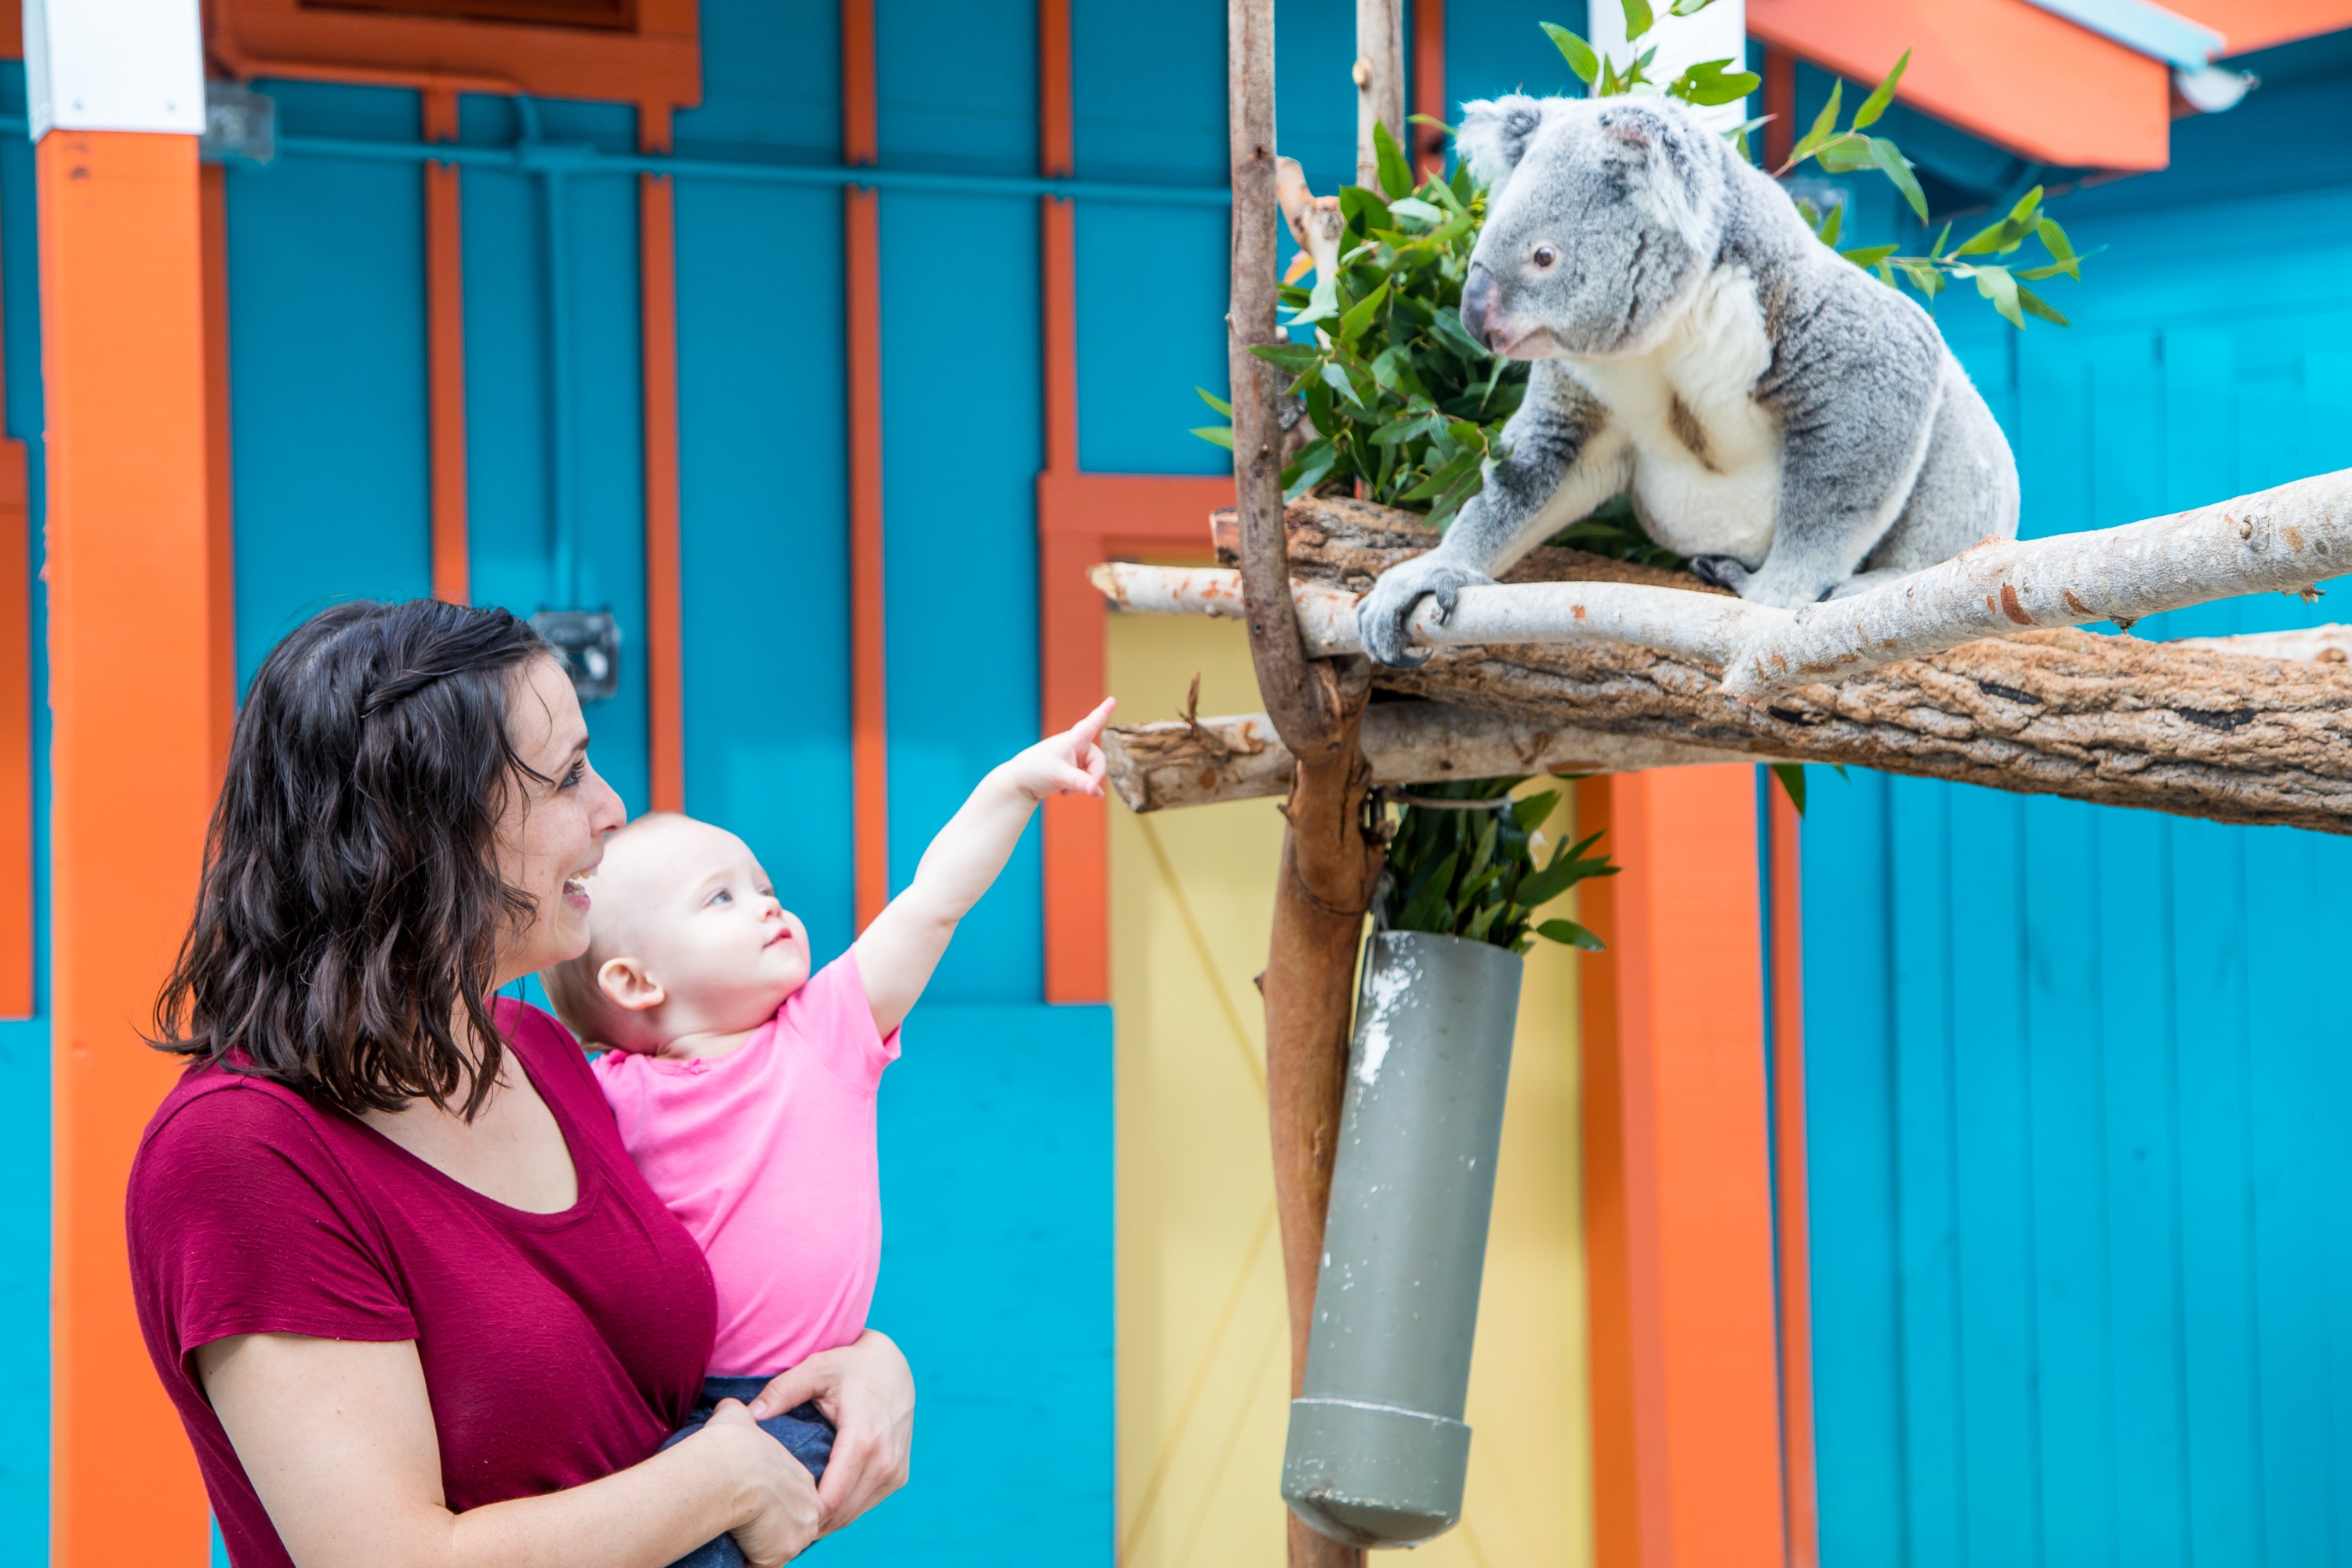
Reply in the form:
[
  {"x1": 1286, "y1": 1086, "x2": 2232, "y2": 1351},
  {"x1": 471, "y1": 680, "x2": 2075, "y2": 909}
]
[{"x1": 842, "y1": 0, "x2": 889, "y2": 926}]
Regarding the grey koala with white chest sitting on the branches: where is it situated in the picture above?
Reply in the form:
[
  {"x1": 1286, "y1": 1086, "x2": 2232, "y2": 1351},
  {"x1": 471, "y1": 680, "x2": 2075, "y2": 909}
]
[{"x1": 1357, "y1": 96, "x2": 2018, "y2": 666}]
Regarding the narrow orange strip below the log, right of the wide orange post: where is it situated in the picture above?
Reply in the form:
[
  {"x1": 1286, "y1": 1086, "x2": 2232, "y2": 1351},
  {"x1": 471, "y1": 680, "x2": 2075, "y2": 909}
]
[{"x1": 1766, "y1": 787, "x2": 1820, "y2": 1568}]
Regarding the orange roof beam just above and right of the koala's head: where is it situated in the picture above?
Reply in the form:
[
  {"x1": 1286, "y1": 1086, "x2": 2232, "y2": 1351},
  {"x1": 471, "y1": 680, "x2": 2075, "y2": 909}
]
[{"x1": 1748, "y1": 0, "x2": 2171, "y2": 169}]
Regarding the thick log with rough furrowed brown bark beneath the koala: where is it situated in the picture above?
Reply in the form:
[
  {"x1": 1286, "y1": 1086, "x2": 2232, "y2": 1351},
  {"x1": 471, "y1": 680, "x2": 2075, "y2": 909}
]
[{"x1": 1157, "y1": 501, "x2": 2352, "y2": 832}]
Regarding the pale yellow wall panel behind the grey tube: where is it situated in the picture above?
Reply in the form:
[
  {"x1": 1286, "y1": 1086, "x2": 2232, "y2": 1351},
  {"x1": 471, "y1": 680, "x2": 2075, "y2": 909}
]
[{"x1": 1110, "y1": 616, "x2": 1592, "y2": 1568}]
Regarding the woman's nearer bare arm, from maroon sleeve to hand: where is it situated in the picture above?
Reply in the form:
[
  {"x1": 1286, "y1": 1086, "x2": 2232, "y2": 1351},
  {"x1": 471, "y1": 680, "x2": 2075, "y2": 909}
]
[{"x1": 195, "y1": 1333, "x2": 818, "y2": 1568}]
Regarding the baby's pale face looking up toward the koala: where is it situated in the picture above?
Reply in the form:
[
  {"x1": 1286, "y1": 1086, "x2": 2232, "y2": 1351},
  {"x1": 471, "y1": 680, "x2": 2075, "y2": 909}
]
[{"x1": 593, "y1": 818, "x2": 809, "y2": 1039}]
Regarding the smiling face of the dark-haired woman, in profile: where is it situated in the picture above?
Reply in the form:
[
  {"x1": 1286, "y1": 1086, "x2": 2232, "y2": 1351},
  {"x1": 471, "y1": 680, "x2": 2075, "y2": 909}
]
[{"x1": 499, "y1": 659, "x2": 628, "y2": 985}]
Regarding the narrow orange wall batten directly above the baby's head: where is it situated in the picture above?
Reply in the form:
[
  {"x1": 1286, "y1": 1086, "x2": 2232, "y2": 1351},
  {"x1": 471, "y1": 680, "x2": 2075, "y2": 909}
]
[{"x1": 637, "y1": 103, "x2": 687, "y2": 811}]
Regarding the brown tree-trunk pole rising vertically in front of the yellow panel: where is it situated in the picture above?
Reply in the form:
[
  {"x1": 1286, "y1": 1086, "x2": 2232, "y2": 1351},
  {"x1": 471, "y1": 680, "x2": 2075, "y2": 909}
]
[{"x1": 1225, "y1": 0, "x2": 1381, "y2": 1568}]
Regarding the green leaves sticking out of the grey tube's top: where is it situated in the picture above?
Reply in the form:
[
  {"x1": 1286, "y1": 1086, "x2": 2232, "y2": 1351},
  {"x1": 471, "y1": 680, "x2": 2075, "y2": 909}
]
[{"x1": 1381, "y1": 779, "x2": 1618, "y2": 952}]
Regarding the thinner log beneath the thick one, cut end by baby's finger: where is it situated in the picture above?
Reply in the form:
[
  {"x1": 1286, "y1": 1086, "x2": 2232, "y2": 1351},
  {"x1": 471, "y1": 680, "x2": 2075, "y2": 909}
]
[{"x1": 1103, "y1": 703, "x2": 1757, "y2": 811}]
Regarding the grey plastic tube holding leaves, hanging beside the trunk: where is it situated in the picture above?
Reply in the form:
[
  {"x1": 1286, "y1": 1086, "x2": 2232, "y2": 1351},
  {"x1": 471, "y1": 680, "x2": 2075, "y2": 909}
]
[{"x1": 1282, "y1": 931, "x2": 1519, "y2": 1547}]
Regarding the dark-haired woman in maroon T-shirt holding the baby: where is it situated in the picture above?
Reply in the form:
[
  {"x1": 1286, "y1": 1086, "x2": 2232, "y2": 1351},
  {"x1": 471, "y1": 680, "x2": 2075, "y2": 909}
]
[{"x1": 127, "y1": 602, "x2": 915, "y2": 1568}]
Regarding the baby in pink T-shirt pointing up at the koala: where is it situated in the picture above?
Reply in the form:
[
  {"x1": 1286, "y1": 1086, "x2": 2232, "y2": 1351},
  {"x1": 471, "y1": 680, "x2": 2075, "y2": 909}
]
[{"x1": 541, "y1": 703, "x2": 1112, "y2": 1568}]
